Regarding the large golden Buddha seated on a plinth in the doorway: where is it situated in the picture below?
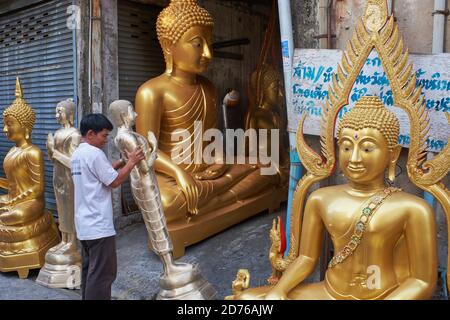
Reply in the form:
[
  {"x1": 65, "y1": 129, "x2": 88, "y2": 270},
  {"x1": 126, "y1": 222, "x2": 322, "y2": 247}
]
[{"x1": 135, "y1": 0, "x2": 287, "y2": 257}]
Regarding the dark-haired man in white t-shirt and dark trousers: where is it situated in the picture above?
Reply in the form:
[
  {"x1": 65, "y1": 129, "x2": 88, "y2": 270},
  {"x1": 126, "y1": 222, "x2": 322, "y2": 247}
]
[{"x1": 71, "y1": 113, "x2": 145, "y2": 300}]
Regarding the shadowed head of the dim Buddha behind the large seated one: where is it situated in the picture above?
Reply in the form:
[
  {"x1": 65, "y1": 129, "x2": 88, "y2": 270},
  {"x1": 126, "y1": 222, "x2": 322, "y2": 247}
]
[{"x1": 250, "y1": 64, "x2": 282, "y2": 108}]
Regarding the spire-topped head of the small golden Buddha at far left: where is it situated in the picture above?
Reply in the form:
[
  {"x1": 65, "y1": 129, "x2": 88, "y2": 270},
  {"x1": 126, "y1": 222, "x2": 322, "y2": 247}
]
[{"x1": 3, "y1": 78, "x2": 36, "y2": 143}]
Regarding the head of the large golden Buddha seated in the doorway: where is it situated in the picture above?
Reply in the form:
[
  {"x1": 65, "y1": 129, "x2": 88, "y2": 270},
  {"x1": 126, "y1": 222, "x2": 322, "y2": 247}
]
[{"x1": 156, "y1": 0, "x2": 214, "y2": 74}]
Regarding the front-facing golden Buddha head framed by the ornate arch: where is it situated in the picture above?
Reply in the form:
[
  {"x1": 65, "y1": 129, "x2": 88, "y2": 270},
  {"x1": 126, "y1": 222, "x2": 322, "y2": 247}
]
[{"x1": 337, "y1": 96, "x2": 401, "y2": 183}]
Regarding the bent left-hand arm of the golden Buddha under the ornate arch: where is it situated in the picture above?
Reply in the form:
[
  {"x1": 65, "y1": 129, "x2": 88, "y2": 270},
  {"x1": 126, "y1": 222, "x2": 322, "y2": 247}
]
[{"x1": 266, "y1": 195, "x2": 325, "y2": 300}]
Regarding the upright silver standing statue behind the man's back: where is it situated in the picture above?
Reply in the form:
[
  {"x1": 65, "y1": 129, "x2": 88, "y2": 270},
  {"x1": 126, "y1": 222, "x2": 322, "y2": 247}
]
[{"x1": 36, "y1": 99, "x2": 81, "y2": 289}]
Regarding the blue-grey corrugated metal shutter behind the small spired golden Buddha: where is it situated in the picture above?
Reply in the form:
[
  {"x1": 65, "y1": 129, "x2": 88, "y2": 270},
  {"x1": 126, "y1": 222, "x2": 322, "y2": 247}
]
[{"x1": 0, "y1": 0, "x2": 76, "y2": 213}]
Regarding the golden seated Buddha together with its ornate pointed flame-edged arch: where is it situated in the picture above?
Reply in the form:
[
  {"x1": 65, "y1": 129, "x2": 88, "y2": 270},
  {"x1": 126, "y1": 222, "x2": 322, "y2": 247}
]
[{"x1": 229, "y1": 0, "x2": 450, "y2": 300}]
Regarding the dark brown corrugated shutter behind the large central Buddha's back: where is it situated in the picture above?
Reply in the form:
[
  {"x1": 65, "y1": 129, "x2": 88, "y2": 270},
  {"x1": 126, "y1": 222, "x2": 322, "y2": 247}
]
[{"x1": 118, "y1": 0, "x2": 165, "y2": 214}]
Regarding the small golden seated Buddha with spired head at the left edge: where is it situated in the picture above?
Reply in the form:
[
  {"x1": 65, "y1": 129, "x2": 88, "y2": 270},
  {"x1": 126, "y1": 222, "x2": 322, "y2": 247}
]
[{"x1": 0, "y1": 78, "x2": 59, "y2": 278}]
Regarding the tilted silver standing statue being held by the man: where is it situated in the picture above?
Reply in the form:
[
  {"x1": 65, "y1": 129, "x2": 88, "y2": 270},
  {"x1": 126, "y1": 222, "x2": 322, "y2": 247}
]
[{"x1": 109, "y1": 100, "x2": 216, "y2": 300}]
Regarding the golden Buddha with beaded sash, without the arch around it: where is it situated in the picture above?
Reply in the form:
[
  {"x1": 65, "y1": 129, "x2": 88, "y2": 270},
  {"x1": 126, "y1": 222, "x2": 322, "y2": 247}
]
[{"x1": 235, "y1": 97, "x2": 437, "y2": 300}]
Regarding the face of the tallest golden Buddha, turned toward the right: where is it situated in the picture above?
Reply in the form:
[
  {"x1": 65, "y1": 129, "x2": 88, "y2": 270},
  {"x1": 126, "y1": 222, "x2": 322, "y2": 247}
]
[{"x1": 171, "y1": 26, "x2": 213, "y2": 74}]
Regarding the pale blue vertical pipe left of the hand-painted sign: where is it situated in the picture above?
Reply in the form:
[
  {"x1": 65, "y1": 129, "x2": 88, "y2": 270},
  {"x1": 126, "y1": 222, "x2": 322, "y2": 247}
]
[{"x1": 278, "y1": 0, "x2": 301, "y2": 252}]
